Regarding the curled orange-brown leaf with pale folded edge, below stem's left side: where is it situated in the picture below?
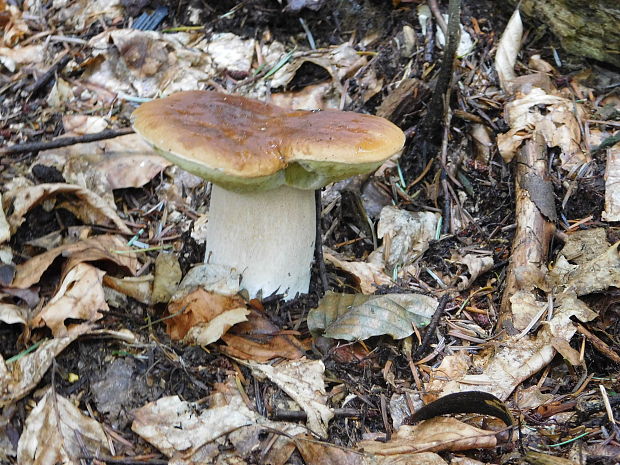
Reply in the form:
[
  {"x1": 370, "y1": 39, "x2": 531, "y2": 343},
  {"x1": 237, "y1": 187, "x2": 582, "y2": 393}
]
[{"x1": 165, "y1": 288, "x2": 249, "y2": 345}]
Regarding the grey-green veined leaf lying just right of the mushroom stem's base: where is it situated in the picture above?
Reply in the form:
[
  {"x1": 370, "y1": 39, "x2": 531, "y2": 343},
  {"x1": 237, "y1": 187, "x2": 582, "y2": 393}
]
[{"x1": 308, "y1": 293, "x2": 437, "y2": 341}]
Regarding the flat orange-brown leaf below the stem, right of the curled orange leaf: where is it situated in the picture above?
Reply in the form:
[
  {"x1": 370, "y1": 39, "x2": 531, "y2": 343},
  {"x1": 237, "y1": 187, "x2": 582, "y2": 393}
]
[{"x1": 221, "y1": 310, "x2": 305, "y2": 362}]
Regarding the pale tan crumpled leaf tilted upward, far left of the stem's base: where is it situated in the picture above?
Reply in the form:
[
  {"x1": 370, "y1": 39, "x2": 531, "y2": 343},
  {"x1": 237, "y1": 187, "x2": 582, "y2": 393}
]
[{"x1": 30, "y1": 263, "x2": 109, "y2": 337}]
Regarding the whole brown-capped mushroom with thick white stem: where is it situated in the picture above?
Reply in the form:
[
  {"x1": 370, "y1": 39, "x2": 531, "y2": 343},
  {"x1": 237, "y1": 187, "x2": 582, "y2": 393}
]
[{"x1": 132, "y1": 91, "x2": 405, "y2": 299}]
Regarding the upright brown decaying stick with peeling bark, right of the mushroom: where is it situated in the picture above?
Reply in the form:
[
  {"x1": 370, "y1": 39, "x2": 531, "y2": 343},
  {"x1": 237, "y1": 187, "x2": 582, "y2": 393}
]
[{"x1": 499, "y1": 134, "x2": 555, "y2": 333}]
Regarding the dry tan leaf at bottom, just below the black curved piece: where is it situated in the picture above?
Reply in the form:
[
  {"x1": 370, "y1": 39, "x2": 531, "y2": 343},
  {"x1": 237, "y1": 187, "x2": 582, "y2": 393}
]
[{"x1": 357, "y1": 417, "x2": 498, "y2": 455}]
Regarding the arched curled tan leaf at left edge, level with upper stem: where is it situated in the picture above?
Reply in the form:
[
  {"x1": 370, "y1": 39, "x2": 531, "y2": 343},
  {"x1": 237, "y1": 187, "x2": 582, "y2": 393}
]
[{"x1": 3, "y1": 183, "x2": 131, "y2": 234}]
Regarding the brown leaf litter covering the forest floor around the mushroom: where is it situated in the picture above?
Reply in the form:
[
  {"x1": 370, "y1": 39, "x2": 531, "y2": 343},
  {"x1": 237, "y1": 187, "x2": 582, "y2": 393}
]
[{"x1": 0, "y1": 1, "x2": 619, "y2": 464}]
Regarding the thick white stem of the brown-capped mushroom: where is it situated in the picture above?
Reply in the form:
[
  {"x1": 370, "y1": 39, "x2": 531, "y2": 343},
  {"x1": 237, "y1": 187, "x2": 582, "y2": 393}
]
[{"x1": 205, "y1": 184, "x2": 316, "y2": 300}]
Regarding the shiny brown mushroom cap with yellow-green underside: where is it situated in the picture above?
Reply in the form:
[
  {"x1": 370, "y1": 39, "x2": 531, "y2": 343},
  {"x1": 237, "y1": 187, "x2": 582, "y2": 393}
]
[{"x1": 133, "y1": 91, "x2": 405, "y2": 191}]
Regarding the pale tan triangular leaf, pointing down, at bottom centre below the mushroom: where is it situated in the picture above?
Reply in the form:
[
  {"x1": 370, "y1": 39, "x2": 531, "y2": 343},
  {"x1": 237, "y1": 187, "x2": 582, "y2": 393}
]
[{"x1": 248, "y1": 359, "x2": 334, "y2": 438}]
